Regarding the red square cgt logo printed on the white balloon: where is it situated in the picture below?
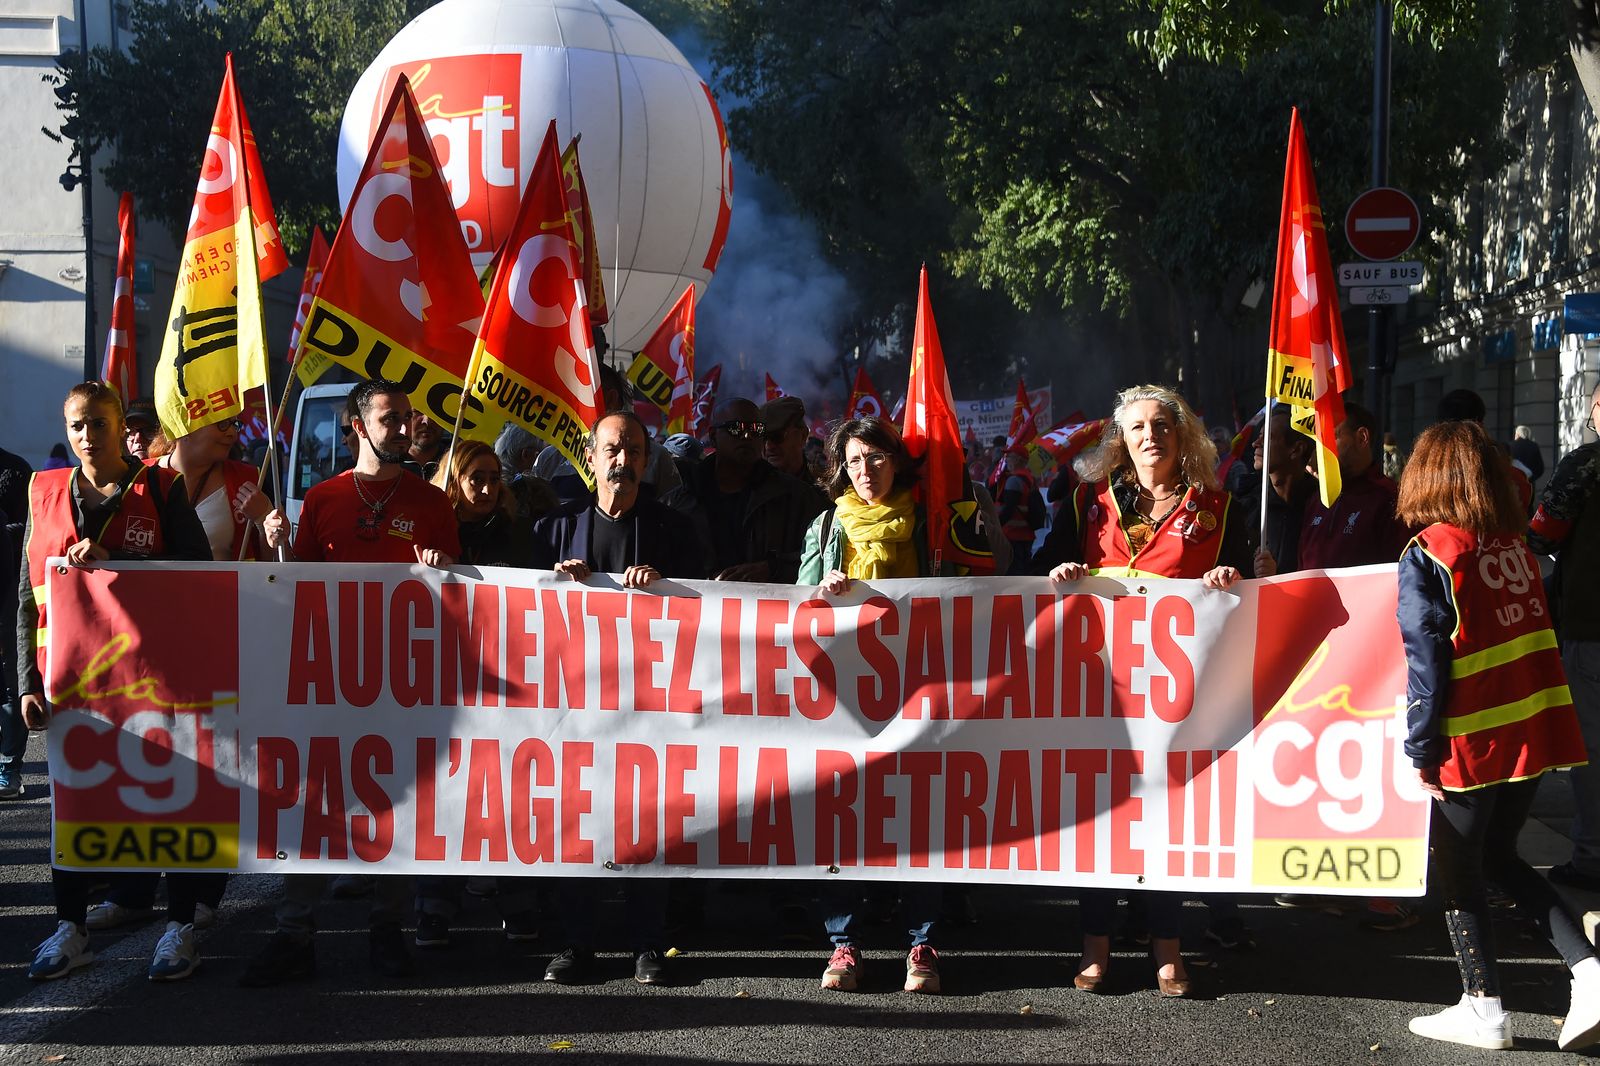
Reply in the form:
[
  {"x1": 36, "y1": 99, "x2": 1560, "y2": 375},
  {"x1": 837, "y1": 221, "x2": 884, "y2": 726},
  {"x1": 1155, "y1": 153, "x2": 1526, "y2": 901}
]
[{"x1": 370, "y1": 53, "x2": 522, "y2": 254}]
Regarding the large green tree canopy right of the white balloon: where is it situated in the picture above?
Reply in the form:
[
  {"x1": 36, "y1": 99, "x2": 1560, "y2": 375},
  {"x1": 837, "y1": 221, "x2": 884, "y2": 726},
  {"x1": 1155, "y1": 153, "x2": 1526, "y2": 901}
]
[{"x1": 710, "y1": 0, "x2": 1525, "y2": 410}]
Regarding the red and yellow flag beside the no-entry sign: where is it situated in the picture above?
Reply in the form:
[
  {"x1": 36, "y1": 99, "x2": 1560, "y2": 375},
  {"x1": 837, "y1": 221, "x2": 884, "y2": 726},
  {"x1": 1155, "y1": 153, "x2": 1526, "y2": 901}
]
[{"x1": 1267, "y1": 109, "x2": 1350, "y2": 506}]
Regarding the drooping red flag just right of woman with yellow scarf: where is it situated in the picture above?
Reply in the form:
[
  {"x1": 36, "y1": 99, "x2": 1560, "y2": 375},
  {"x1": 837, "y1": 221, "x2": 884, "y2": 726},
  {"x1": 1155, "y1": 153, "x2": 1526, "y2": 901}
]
[{"x1": 904, "y1": 267, "x2": 995, "y2": 576}]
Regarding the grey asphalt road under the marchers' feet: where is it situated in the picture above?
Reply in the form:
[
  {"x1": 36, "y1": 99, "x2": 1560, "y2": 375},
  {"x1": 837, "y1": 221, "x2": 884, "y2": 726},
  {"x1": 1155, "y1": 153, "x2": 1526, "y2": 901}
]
[{"x1": 0, "y1": 738, "x2": 1581, "y2": 1066}]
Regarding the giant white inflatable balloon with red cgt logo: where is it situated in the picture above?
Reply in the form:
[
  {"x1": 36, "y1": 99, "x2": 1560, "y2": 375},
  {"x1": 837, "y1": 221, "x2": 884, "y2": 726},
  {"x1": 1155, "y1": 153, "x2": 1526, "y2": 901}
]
[{"x1": 339, "y1": 0, "x2": 733, "y2": 351}]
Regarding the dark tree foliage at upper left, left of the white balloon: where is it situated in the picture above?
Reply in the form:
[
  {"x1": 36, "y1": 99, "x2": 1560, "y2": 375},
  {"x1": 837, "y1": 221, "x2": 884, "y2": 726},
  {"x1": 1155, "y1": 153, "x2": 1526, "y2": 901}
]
[{"x1": 59, "y1": 0, "x2": 429, "y2": 250}]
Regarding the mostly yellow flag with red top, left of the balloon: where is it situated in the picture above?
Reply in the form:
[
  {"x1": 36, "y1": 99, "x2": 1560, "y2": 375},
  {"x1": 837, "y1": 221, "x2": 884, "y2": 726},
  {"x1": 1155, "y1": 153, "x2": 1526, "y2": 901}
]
[{"x1": 155, "y1": 53, "x2": 290, "y2": 440}]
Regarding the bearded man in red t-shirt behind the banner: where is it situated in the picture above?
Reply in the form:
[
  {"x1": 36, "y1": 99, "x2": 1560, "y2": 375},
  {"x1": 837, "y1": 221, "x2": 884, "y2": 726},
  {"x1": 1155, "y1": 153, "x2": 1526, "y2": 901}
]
[{"x1": 240, "y1": 379, "x2": 461, "y2": 988}]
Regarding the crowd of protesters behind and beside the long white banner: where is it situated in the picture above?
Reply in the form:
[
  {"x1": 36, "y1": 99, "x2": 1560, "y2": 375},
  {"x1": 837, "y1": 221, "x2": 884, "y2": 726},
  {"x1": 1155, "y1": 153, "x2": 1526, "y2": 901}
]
[{"x1": 9, "y1": 368, "x2": 1600, "y2": 1048}]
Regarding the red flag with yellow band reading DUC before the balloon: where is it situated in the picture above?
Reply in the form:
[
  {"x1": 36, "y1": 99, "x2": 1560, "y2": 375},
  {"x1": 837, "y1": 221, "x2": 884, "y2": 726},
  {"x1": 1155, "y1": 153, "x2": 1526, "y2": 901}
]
[{"x1": 296, "y1": 77, "x2": 483, "y2": 432}]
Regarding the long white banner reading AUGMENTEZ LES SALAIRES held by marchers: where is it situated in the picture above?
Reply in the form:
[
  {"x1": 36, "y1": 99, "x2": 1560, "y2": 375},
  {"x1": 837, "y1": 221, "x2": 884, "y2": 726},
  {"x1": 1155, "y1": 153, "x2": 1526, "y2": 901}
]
[{"x1": 48, "y1": 563, "x2": 1427, "y2": 895}]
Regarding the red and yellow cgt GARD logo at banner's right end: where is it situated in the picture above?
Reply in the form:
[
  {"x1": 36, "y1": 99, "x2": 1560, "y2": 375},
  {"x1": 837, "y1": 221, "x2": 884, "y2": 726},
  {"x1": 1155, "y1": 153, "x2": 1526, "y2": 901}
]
[{"x1": 1251, "y1": 568, "x2": 1429, "y2": 895}]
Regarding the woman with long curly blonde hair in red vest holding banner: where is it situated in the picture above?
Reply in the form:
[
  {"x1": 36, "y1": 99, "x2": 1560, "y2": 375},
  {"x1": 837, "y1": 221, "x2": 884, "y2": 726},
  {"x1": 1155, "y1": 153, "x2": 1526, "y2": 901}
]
[{"x1": 1034, "y1": 386, "x2": 1251, "y2": 996}]
